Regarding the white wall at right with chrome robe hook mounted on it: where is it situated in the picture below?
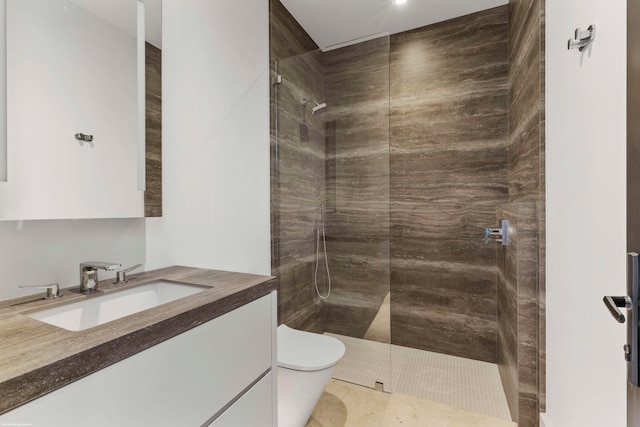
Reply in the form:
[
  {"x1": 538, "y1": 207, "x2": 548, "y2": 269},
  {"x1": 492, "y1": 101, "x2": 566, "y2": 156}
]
[{"x1": 546, "y1": 0, "x2": 626, "y2": 427}]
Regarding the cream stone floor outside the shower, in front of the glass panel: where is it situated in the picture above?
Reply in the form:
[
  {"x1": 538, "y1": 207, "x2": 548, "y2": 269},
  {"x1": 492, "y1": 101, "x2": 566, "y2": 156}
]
[{"x1": 306, "y1": 379, "x2": 517, "y2": 427}]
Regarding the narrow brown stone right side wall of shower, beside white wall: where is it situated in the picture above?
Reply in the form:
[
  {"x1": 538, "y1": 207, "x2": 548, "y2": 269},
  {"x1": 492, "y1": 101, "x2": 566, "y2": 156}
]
[{"x1": 509, "y1": 0, "x2": 546, "y2": 425}]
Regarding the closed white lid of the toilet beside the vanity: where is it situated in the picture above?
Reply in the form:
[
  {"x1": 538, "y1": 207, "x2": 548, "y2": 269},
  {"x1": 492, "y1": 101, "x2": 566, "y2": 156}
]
[{"x1": 278, "y1": 325, "x2": 345, "y2": 371}]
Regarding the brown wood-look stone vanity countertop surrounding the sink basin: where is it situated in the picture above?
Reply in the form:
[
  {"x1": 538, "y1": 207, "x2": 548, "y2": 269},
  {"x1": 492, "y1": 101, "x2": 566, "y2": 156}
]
[{"x1": 0, "y1": 266, "x2": 277, "y2": 414}]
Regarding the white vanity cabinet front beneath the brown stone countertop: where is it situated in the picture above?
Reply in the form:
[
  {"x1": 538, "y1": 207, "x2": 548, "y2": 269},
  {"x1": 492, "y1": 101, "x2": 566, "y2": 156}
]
[{"x1": 0, "y1": 291, "x2": 277, "y2": 427}]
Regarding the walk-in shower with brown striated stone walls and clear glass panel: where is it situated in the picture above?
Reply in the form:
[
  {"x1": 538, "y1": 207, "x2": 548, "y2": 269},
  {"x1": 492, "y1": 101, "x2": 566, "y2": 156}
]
[{"x1": 272, "y1": 2, "x2": 536, "y2": 424}]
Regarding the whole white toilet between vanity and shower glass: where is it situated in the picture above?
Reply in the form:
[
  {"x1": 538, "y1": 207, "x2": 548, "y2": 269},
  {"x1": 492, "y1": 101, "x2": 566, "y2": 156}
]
[{"x1": 278, "y1": 325, "x2": 345, "y2": 427}]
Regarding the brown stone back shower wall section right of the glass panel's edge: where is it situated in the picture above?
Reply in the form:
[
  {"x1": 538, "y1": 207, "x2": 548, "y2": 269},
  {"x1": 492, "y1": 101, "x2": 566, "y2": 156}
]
[{"x1": 390, "y1": 7, "x2": 509, "y2": 362}]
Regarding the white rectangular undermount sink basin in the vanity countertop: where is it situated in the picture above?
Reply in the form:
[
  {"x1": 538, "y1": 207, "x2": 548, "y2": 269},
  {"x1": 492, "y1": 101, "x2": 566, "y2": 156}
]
[{"x1": 27, "y1": 280, "x2": 211, "y2": 331}]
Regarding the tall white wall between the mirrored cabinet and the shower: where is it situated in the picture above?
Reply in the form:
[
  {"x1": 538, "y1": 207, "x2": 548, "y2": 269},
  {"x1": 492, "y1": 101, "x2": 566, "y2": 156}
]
[{"x1": 147, "y1": 0, "x2": 271, "y2": 274}]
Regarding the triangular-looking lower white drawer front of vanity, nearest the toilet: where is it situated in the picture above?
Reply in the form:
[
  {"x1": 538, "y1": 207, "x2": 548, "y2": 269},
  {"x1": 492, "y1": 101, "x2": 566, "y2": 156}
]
[{"x1": 209, "y1": 372, "x2": 273, "y2": 427}]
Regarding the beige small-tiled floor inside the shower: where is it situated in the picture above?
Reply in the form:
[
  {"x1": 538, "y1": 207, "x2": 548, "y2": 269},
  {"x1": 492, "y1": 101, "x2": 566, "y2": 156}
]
[{"x1": 328, "y1": 334, "x2": 511, "y2": 420}]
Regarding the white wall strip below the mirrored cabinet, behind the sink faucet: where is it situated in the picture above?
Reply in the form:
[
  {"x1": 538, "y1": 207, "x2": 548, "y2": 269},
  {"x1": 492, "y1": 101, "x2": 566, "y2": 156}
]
[{"x1": 0, "y1": 219, "x2": 145, "y2": 300}]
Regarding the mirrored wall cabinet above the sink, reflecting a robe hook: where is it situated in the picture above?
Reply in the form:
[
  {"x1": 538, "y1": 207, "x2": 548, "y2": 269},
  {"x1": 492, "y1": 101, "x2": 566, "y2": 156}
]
[{"x1": 0, "y1": 0, "x2": 162, "y2": 220}]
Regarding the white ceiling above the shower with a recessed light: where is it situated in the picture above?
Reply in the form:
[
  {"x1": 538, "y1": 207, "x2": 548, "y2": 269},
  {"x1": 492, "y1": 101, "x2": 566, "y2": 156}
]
[{"x1": 281, "y1": 0, "x2": 509, "y2": 51}]
